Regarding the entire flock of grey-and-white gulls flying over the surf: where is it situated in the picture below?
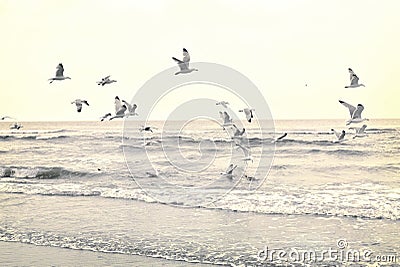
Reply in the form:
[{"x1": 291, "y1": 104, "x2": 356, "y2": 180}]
[{"x1": 0, "y1": 48, "x2": 368, "y2": 181}]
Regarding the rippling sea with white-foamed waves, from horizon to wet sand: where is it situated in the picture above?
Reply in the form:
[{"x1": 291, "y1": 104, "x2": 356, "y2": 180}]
[{"x1": 0, "y1": 120, "x2": 400, "y2": 266}]
